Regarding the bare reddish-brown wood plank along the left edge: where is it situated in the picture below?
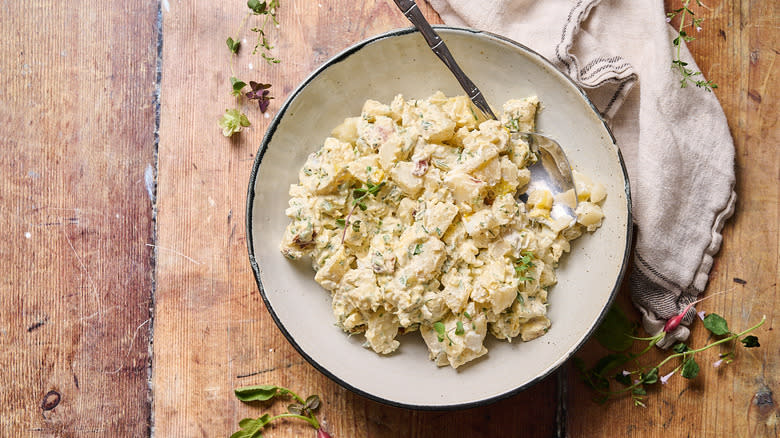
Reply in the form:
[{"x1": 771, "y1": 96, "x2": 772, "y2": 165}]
[{"x1": 0, "y1": 0, "x2": 157, "y2": 437}]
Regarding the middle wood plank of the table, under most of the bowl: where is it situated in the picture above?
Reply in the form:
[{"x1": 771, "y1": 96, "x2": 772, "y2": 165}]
[{"x1": 153, "y1": 0, "x2": 555, "y2": 437}]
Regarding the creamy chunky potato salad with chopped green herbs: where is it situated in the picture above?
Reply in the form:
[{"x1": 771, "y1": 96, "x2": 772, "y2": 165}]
[{"x1": 280, "y1": 92, "x2": 606, "y2": 368}]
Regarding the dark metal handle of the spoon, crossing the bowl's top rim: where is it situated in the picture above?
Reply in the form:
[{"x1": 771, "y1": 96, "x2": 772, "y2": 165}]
[{"x1": 394, "y1": 0, "x2": 497, "y2": 120}]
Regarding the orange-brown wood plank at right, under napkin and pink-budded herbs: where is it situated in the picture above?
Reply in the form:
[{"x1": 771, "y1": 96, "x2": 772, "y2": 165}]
[{"x1": 570, "y1": 0, "x2": 780, "y2": 437}]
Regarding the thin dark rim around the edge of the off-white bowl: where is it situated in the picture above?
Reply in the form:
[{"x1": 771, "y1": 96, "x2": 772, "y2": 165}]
[{"x1": 246, "y1": 25, "x2": 633, "y2": 411}]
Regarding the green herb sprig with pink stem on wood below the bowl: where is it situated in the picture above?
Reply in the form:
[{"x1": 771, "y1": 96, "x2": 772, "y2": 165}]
[{"x1": 230, "y1": 385, "x2": 330, "y2": 438}]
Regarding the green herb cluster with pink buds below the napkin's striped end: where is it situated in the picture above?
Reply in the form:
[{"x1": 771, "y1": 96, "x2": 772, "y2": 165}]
[{"x1": 573, "y1": 307, "x2": 766, "y2": 407}]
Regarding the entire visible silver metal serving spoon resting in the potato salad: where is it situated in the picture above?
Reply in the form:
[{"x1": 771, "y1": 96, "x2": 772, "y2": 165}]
[{"x1": 394, "y1": 0, "x2": 577, "y2": 219}]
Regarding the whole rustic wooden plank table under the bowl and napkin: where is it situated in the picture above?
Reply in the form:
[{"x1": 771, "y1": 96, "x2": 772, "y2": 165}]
[{"x1": 0, "y1": 0, "x2": 780, "y2": 437}]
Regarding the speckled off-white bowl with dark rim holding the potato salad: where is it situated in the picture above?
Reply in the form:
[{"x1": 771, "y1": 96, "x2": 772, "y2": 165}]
[{"x1": 247, "y1": 27, "x2": 631, "y2": 409}]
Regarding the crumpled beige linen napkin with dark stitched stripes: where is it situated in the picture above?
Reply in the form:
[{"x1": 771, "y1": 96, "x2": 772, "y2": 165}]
[{"x1": 429, "y1": 0, "x2": 736, "y2": 348}]
